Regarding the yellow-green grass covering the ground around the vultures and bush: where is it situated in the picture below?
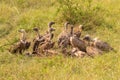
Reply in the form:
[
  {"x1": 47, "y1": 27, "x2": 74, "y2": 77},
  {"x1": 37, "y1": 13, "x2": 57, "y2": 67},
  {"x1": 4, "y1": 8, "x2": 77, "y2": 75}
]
[{"x1": 0, "y1": 0, "x2": 120, "y2": 80}]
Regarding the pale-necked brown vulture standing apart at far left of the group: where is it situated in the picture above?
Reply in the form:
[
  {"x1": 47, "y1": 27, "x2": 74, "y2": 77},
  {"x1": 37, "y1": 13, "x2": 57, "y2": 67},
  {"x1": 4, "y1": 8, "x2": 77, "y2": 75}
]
[{"x1": 10, "y1": 29, "x2": 31, "y2": 54}]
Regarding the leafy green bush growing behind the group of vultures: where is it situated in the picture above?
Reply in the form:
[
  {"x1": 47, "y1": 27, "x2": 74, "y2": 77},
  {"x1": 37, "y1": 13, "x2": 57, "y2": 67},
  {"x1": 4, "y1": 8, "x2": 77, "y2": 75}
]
[{"x1": 57, "y1": 0, "x2": 108, "y2": 30}]
